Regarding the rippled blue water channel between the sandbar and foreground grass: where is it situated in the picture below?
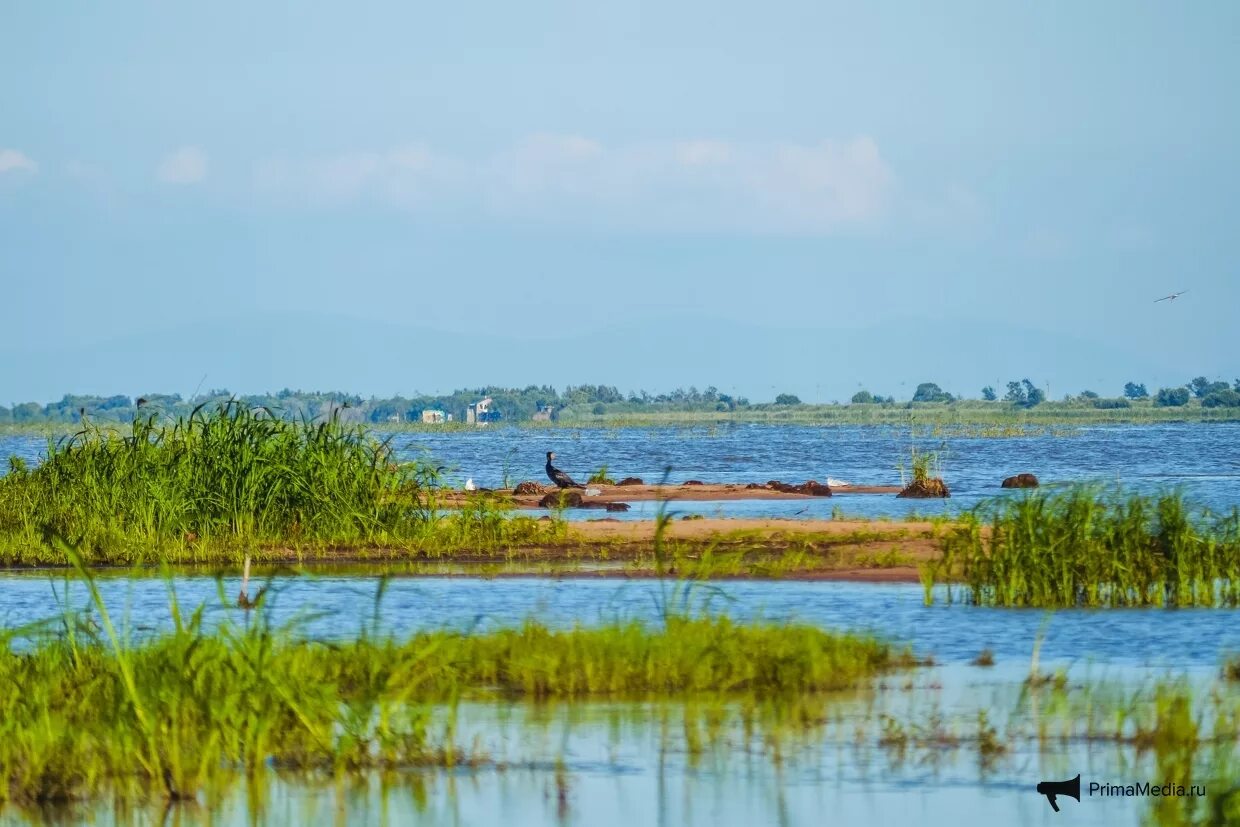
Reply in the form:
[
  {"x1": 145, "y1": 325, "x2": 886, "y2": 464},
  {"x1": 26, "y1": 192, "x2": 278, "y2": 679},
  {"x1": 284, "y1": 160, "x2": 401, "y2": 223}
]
[{"x1": 0, "y1": 573, "x2": 1240, "y2": 671}]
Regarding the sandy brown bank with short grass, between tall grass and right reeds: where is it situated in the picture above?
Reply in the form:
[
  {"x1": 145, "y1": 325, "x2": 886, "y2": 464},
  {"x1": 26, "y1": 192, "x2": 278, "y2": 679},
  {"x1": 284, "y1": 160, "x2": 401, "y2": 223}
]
[{"x1": 0, "y1": 517, "x2": 942, "y2": 583}]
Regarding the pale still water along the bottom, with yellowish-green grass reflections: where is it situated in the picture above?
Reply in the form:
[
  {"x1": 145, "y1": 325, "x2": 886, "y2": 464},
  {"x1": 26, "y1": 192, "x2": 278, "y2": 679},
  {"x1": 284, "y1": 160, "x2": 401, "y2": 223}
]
[{"x1": 7, "y1": 666, "x2": 1236, "y2": 827}]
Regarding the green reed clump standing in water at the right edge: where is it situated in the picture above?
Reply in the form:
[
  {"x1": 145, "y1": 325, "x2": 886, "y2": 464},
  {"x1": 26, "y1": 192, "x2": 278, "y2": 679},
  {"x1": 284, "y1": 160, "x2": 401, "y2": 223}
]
[{"x1": 926, "y1": 486, "x2": 1240, "y2": 608}]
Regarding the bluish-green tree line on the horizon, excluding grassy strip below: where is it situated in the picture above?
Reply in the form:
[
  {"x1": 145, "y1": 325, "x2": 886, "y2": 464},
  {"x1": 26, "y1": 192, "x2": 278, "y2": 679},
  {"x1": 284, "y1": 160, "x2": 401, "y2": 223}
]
[{"x1": 0, "y1": 376, "x2": 1240, "y2": 424}]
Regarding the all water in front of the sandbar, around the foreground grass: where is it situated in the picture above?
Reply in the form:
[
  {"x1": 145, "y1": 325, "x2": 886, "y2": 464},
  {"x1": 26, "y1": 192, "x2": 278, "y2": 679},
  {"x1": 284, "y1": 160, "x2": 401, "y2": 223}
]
[{"x1": 0, "y1": 572, "x2": 1240, "y2": 827}]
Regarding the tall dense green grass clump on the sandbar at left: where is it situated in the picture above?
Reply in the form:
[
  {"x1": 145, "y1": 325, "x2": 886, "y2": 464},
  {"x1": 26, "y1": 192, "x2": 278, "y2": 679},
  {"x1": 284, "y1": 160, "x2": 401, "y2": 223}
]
[{"x1": 0, "y1": 402, "x2": 553, "y2": 564}]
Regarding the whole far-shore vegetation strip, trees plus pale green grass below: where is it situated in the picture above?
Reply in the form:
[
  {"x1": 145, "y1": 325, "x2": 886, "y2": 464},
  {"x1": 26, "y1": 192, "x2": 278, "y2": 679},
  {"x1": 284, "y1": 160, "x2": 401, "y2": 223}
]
[{"x1": 0, "y1": 377, "x2": 1240, "y2": 430}]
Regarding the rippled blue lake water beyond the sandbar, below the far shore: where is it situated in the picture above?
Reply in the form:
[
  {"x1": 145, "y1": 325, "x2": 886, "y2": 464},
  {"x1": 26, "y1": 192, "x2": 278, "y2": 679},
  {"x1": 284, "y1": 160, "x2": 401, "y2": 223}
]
[{"x1": 12, "y1": 423, "x2": 1240, "y2": 518}]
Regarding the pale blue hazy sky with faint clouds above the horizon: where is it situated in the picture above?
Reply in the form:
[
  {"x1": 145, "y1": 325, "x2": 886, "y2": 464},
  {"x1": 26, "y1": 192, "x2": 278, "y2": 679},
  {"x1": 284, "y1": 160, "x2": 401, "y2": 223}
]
[{"x1": 0, "y1": 0, "x2": 1240, "y2": 404}]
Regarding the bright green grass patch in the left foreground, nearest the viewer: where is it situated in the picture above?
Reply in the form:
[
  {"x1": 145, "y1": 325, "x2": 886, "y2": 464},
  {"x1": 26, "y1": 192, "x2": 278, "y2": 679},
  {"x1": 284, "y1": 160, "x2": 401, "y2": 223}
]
[{"x1": 0, "y1": 560, "x2": 911, "y2": 803}]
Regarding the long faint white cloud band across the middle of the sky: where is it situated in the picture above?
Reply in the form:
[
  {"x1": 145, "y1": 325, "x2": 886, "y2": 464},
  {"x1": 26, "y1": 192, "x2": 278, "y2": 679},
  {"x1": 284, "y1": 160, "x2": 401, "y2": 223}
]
[{"x1": 255, "y1": 133, "x2": 895, "y2": 234}]
